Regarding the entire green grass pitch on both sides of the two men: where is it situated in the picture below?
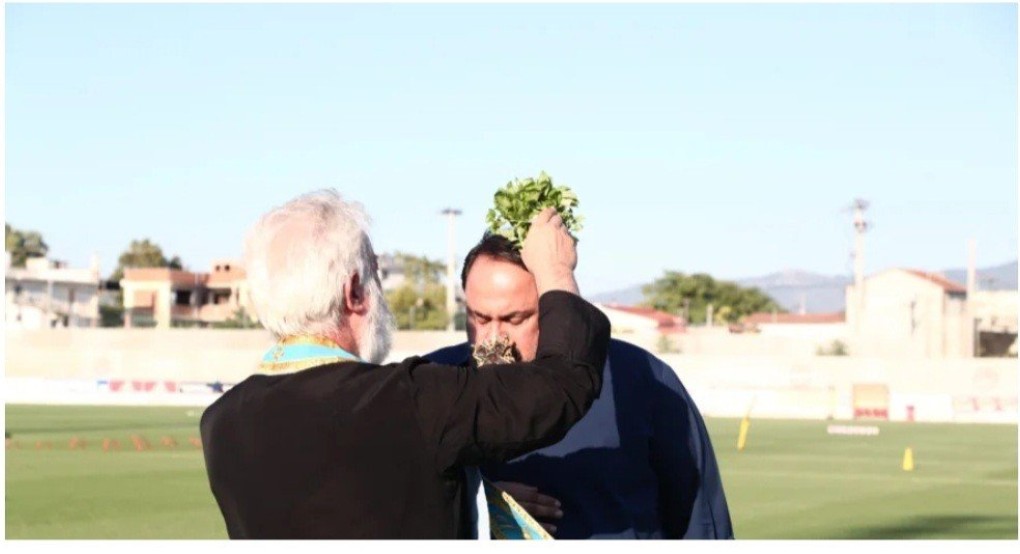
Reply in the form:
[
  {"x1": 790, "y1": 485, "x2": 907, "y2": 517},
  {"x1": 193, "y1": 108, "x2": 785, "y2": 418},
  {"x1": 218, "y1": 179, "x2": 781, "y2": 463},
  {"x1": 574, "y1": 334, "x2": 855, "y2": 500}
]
[{"x1": 6, "y1": 405, "x2": 1017, "y2": 540}]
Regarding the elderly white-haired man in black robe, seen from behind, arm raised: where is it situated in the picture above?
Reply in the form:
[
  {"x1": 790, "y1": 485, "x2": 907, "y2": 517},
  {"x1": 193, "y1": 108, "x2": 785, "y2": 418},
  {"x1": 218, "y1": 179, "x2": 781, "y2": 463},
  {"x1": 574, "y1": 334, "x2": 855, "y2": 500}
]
[{"x1": 201, "y1": 191, "x2": 609, "y2": 539}]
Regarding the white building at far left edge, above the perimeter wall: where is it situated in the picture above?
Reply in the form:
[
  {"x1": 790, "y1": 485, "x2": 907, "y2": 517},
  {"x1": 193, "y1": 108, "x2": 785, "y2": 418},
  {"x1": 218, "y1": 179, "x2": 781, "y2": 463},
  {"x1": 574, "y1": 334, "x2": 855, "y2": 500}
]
[{"x1": 4, "y1": 252, "x2": 101, "y2": 329}]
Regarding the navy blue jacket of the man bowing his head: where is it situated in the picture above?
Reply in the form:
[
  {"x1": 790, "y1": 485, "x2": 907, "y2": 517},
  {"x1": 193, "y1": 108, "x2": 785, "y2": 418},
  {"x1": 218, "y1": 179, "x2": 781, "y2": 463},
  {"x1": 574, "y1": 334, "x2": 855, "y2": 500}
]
[{"x1": 426, "y1": 339, "x2": 733, "y2": 539}]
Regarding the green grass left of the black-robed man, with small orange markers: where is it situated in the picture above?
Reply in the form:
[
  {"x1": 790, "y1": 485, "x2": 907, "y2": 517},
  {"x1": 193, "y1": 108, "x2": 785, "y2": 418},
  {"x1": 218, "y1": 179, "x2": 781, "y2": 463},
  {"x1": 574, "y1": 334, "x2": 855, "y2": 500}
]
[{"x1": 6, "y1": 405, "x2": 226, "y2": 539}]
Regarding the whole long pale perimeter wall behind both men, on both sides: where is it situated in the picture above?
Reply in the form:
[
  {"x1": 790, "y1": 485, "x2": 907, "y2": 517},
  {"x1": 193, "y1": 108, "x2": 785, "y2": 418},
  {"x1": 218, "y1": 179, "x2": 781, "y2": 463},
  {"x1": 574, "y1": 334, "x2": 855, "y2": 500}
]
[{"x1": 4, "y1": 329, "x2": 1017, "y2": 422}]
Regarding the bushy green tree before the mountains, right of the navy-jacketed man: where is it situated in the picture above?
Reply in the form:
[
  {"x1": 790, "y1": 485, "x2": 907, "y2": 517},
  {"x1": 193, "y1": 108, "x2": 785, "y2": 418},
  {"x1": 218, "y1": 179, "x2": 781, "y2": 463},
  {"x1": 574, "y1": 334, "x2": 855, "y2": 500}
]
[{"x1": 642, "y1": 271, "x2": 783, "y2": 323}]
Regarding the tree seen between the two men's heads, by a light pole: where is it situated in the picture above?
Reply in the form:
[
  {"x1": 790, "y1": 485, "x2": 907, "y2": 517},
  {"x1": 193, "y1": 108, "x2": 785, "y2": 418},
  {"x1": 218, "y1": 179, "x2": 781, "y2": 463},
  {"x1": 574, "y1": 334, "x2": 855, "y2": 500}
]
[{"x1": 386, "y1": 252, "x2": 447, "y2": 330}]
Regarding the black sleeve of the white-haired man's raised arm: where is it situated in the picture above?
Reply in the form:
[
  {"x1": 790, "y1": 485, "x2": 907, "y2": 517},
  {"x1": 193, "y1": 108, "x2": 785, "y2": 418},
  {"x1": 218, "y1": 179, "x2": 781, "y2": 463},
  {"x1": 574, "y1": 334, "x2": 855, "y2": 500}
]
[{"x1": 404, "y1": 291, "x2": 609, "y2": 470}]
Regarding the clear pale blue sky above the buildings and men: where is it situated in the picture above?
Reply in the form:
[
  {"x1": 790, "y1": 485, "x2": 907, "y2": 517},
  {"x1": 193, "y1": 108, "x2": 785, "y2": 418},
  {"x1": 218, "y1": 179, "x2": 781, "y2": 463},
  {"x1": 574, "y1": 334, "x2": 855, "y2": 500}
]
[{"x1": 4, "y1": 4, "x2": 1017, "y2": 293}]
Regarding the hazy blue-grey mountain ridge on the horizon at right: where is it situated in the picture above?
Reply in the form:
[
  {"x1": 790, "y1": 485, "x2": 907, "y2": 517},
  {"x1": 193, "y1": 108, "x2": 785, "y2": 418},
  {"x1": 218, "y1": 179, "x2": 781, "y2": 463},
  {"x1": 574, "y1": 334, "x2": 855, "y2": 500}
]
[{"x1": 590, "y1": 261, "x2": 1017, "y2": 313}]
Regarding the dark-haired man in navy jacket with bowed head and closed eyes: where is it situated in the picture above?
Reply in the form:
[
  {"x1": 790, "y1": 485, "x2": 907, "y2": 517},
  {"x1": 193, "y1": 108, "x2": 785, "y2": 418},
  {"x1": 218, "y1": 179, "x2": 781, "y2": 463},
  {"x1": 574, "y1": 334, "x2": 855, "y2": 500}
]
[{"x1": 427, "y1": 234, "x2": 733, "y2": 539}]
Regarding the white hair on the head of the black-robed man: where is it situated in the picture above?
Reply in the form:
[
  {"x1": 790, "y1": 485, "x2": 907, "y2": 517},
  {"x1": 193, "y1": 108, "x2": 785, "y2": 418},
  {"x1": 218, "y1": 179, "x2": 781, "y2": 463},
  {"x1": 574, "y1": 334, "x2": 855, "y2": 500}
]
[{"x1": 244, "y1": 189, "x2": 389, "y2": 342}]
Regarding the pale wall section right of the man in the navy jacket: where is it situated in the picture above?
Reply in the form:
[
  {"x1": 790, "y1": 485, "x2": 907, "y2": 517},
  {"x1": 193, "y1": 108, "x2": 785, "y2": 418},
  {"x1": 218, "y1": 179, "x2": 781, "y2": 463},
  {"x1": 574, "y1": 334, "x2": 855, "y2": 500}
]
[{"x1": 660, "y1": 355, "x2": 1017, "y2": 423}]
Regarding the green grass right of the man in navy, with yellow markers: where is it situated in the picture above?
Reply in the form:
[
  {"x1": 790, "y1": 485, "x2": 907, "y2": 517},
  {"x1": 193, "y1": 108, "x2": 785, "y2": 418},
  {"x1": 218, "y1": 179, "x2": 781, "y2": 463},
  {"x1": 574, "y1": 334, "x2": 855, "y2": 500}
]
[{"x1": 708, "y1": 419, "x2": 1017, "y2": 540}]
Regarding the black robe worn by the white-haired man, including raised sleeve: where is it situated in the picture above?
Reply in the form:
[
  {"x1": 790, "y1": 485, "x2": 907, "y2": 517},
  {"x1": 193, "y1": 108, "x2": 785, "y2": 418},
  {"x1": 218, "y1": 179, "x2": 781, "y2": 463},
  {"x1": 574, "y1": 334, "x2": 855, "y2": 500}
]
[{"x1": 201, "y1": 291, "x2": 609, "y2": 539}]
